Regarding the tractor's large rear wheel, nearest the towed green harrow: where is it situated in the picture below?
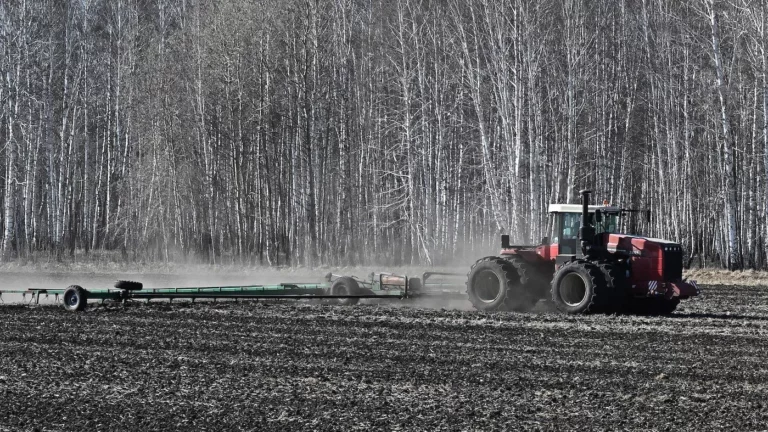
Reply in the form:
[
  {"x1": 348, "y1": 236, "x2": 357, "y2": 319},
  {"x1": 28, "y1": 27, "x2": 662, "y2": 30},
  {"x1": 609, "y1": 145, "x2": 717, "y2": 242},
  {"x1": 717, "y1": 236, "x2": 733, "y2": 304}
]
[{"x1": 467, "y1": 257, "x2": 533, "y2": 312}]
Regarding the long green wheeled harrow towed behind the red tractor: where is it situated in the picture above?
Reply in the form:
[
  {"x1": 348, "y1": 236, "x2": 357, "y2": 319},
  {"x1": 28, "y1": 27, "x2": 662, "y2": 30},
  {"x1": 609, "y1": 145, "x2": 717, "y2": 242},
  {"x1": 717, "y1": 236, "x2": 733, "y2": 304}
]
[{"x1": 0, "y1": 272, "x2": 465, "y2": 311}]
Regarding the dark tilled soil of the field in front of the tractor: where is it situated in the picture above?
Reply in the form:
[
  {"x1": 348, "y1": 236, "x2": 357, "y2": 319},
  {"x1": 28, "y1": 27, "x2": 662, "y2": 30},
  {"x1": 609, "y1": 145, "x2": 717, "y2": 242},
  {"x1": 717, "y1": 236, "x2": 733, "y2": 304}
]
[{"x1": 0, "y1": 286, "x2": 768, "y2": 431}]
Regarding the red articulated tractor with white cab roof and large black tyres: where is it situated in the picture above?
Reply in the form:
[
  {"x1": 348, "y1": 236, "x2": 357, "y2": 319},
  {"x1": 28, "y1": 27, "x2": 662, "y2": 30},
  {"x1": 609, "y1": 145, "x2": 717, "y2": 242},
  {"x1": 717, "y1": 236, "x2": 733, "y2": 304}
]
[{"x1": 467, "y1": 190, "x2": 699, "y2": 315}]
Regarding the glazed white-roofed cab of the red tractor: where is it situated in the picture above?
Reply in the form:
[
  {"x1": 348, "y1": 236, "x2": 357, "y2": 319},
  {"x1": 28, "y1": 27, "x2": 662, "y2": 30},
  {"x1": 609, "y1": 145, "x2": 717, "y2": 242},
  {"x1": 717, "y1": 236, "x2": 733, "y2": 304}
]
[{"x1": 548, "y1": 204, "x2": 622, "y2": 255}]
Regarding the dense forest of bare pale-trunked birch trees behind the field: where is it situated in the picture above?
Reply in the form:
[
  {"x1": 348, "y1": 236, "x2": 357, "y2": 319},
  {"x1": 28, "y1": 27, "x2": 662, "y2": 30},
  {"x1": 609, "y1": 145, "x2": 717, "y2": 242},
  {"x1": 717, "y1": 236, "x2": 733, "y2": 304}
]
[{"x1": 0, "y1": 0, "x2": 768, "y2": 269}]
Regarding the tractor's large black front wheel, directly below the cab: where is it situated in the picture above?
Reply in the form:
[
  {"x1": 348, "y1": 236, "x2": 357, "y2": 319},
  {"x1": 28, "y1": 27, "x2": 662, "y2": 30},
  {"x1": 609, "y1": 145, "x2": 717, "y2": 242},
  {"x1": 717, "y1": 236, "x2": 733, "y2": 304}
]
[{"x1": 552, "y1": 260, "x2": 607, "y2": 314}]
